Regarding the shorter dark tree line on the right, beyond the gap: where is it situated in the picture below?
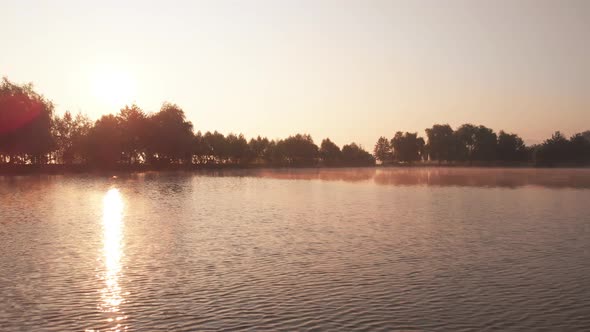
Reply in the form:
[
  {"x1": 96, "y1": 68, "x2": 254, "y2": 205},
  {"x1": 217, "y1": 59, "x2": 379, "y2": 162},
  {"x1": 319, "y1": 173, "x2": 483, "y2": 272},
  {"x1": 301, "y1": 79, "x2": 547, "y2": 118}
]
[{"x1": 374, "y1": 124, "x2": 590, "y2": 166}]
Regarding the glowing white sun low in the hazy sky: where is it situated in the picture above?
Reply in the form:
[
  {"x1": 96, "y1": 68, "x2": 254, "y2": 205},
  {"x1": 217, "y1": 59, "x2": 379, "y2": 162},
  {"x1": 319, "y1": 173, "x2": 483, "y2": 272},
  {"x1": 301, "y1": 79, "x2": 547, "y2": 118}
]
[{"x1": 92, "y1": 69, "x2": 136, "y2": 107}]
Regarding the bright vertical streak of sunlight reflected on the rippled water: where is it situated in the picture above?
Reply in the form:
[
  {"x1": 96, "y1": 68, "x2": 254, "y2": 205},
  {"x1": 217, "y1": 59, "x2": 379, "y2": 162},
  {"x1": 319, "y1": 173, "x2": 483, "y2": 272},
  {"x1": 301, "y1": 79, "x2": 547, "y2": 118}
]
[{"x1": 99, "y1": 188, "x2": 126, "y2": 331}]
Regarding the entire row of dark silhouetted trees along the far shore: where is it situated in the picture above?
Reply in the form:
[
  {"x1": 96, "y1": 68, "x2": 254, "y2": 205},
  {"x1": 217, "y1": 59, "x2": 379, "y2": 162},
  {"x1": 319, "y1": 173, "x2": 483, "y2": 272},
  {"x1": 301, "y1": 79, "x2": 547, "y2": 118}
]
[{"x1": 0, "y1": 78, "x2": 590, "y2": 168}]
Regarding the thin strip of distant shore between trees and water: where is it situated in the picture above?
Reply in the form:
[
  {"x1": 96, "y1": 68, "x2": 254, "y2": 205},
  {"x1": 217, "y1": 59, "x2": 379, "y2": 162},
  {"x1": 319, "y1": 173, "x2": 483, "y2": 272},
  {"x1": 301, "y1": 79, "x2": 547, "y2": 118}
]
[{"x1": 0, "y1": 162, "x2": 590, "y2": 176}]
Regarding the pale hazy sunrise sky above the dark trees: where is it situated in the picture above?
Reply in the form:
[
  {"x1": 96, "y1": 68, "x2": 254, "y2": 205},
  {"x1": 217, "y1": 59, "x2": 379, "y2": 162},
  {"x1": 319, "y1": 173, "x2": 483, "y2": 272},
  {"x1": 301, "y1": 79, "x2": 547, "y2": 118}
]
[{"x1": 0, "y1": 0, "x2": 590, "y2": 149}]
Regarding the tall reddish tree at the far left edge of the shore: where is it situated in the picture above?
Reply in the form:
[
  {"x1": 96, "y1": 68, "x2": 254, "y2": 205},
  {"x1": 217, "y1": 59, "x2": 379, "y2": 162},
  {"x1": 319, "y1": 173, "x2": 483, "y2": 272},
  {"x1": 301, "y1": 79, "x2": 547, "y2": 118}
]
[{"x1": 0, "y1": 78, "x2": 55, "y2": 164}]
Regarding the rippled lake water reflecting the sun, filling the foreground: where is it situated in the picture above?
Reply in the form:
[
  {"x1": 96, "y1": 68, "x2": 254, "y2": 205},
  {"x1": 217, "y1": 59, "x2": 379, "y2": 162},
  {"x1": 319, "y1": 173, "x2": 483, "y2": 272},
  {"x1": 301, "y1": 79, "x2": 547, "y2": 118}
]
[{"x1": 0, "y1": 168, "x2": 590, "y2": 331}]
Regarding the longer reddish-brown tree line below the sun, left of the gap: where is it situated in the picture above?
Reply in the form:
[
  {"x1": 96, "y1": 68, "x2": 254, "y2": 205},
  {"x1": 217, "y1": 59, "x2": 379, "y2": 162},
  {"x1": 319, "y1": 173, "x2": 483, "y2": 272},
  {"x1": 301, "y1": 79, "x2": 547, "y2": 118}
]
[{"x1": 0, "y1": 78, "x2": 375, "y2": 167}]
